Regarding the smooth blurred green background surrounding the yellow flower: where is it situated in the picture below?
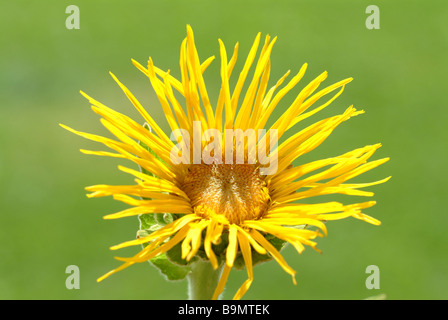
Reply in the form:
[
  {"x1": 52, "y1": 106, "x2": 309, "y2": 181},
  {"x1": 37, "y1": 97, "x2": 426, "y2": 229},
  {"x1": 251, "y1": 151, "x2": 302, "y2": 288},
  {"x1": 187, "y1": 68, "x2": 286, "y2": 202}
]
[{"x1": 0, "y1": 0, "x2": 448, "y2": 299}]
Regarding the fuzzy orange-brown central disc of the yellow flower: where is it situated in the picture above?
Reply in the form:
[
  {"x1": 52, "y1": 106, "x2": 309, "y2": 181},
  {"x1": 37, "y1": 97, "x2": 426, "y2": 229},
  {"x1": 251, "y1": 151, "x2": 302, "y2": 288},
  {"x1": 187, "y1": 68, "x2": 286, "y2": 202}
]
[{"x1": 182, "y1": 164, "x2": 270, "y2": 224}]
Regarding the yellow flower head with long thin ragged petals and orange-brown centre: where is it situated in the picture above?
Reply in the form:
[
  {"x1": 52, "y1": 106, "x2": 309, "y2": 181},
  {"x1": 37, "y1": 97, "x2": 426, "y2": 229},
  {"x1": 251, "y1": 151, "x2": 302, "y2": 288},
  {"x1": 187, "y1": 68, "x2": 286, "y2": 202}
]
[{"x1": 59, "y1": 26, "x2": 388, "y2": 299}]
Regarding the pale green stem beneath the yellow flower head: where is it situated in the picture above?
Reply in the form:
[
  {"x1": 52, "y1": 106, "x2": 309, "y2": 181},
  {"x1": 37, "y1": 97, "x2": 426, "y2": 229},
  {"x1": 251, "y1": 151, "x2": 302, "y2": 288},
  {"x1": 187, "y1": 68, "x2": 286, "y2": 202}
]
[{"x1": 188, "y1": 259, "x2": 224, "y2": 300}]
